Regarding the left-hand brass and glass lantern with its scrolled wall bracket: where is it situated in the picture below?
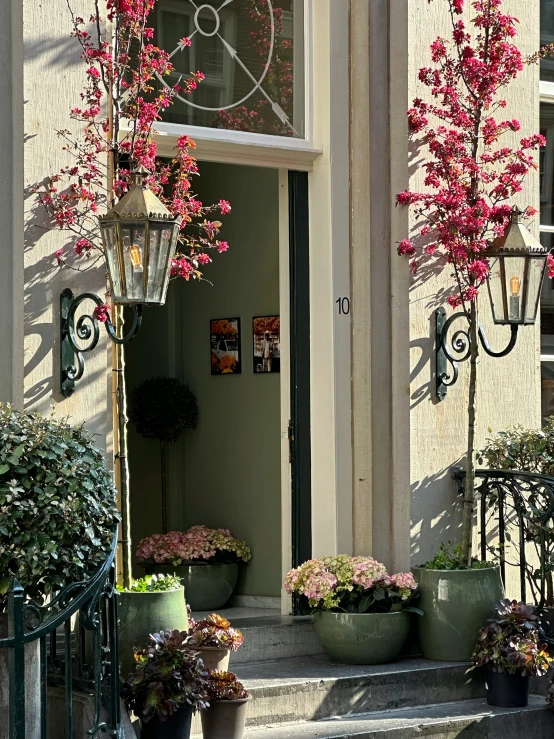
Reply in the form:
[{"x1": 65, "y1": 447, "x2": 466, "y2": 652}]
[{"x1": 60, "y1": 173, "x2": 182, "y2": 398}]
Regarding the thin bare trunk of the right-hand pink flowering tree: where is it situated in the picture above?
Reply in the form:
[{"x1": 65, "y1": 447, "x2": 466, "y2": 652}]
[{"x1": 462, "y1": 300, "x2": 479, "y2": 565}]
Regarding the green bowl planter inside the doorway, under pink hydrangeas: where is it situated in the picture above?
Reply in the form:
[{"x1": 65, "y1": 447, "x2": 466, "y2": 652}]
[{"x1": 147, "y1": 563, "x2": 239, "y2": 611}]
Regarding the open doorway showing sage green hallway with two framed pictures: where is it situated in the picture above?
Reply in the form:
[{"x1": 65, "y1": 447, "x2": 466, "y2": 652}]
[{"x1": 123, "y1": 162, "x2": 311, "y2": 608}]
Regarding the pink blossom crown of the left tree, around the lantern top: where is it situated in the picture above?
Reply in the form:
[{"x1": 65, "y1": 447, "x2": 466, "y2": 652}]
[{"x1": 34, "y1": 0, "x2": 230, "y2": 312}]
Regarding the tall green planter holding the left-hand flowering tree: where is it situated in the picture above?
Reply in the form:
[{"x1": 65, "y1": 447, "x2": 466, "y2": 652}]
[{"x1": 118, "y1": 586, "x2": 188, "y2": 678}]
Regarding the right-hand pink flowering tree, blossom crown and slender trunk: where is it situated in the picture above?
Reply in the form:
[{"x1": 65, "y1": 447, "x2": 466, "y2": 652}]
[{"x1": 396, "y1": 0, "x2": 554, "y2": 563}]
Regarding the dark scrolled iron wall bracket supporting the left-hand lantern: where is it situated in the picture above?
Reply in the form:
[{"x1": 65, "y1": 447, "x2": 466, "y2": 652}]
[{"x1": 60, "y1": 288, "x2": 142, "y2": 398}]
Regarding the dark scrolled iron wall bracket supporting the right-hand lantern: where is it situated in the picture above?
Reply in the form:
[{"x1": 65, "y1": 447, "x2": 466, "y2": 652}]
[{"x1": 435, "y1": 308, "x2": 519, "y2": 400}]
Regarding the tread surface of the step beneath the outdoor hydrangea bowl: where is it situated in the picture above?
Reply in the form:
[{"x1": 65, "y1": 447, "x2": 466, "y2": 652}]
[{"x1": 230, "y1": 655, "x2": 467, "y2": 690}]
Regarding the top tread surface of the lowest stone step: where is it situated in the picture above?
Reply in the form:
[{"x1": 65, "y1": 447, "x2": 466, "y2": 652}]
[{"x1": 245, "y1": 695, "x2": 554, "y2": 739}]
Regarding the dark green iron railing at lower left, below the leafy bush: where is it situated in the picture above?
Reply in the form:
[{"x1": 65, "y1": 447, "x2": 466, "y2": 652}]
[{"x1": 0, "y1": 535, "x2": 124, "y2": 739}]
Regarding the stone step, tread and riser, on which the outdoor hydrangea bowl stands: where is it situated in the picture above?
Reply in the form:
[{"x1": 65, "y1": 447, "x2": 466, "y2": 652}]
[{"x1": 193, "y1": 656, "x2": 484, "y2": 733}]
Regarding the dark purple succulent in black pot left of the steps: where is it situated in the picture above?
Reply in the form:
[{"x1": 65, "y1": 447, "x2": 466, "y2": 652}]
[{"x1": 122, "y1": 630, "x2": 208, "y2": 739}]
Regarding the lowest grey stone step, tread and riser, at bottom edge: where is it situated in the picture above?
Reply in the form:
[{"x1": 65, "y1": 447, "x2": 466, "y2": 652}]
[{"x1": 238, "y1": 696, "x2": 554, "y2": 739}]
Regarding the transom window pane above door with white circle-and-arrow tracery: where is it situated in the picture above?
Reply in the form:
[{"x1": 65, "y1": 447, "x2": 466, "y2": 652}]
[{"x1": 153, "y1": 0, "x2": 305, "y2": 138}]
